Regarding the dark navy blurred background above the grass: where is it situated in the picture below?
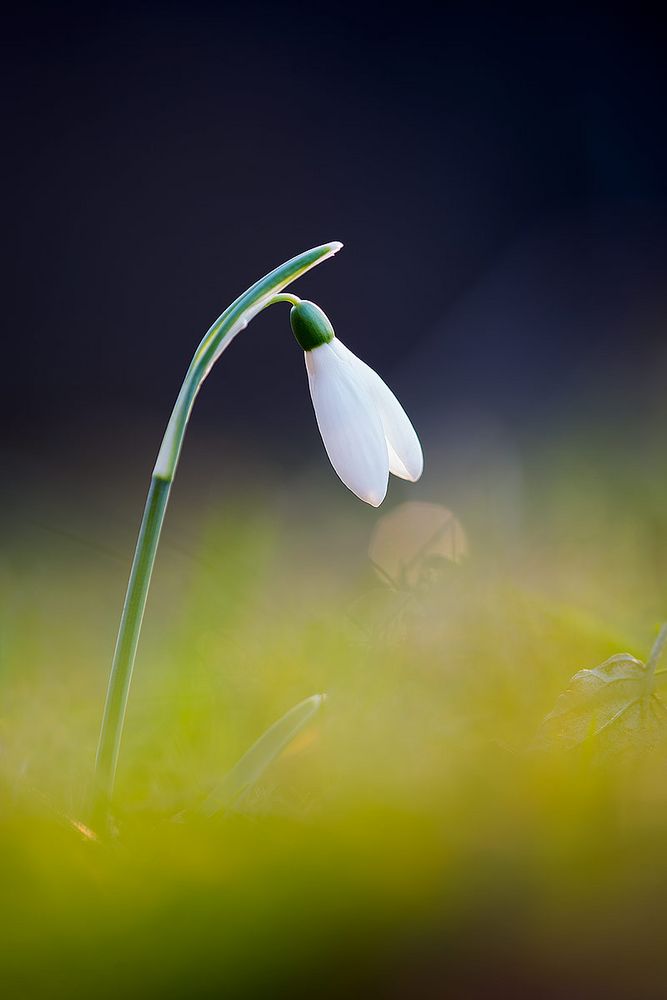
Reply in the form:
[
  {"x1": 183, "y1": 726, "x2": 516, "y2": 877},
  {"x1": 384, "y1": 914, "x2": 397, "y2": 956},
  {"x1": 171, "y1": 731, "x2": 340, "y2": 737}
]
[{"x1": 0, "y1": 2, "x2": 667, "y2": 458}]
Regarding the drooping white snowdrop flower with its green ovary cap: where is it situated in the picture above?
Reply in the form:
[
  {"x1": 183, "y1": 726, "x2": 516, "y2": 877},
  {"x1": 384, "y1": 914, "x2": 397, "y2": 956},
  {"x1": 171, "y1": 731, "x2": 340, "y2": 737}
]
[{"x1": 290, "y1": 300, "x2": 424, "y2": 507}]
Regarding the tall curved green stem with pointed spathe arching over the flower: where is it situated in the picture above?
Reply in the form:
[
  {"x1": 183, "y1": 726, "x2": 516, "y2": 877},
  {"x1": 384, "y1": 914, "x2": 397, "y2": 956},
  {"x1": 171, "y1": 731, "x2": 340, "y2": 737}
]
[{"x1": 96, "y1": 243, "x2": 342, "y2": 805}]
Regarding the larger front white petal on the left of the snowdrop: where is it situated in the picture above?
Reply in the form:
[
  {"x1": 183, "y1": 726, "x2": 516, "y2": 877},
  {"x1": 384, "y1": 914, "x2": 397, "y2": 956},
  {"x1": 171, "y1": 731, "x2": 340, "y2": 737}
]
[{"x1": 305, "y1": 344, "x2": 389, "y2": 507}]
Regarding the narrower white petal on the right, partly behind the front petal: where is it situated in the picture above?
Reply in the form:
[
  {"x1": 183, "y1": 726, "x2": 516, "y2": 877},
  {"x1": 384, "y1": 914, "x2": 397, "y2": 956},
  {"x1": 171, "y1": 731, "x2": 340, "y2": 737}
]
[{"x1": 331, "y1": 337, "x2": 424, "y2": 483}]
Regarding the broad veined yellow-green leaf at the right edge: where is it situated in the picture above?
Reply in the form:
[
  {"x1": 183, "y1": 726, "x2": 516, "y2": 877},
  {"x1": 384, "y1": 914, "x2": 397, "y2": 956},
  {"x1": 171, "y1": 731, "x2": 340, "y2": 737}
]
[{"x1": 538, "y1": 653, "x2": 667, "y2": 750}]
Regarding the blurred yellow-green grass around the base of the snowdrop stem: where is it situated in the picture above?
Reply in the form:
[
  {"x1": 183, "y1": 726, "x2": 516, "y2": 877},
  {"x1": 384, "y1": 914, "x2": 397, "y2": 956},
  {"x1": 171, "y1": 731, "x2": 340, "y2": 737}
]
[{"x1": 0, "y1": 440, "x2": 667, "y2": 997}]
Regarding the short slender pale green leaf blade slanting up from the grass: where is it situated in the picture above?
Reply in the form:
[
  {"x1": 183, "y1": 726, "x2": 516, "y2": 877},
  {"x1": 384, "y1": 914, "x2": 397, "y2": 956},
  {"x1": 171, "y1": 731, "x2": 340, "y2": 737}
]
[{"x1": 199, "y1": 694, "x2": 326, "y2": 816}]
